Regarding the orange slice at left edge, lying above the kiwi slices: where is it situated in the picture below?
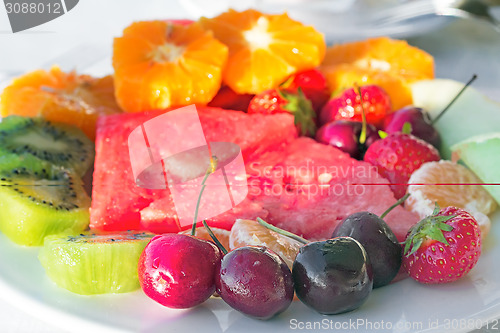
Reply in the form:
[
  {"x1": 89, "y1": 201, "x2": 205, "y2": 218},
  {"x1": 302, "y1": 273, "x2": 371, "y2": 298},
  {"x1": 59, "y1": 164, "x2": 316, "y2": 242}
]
[{"x1": 0, "y1": 66, "x2": 121, "y2": 139}]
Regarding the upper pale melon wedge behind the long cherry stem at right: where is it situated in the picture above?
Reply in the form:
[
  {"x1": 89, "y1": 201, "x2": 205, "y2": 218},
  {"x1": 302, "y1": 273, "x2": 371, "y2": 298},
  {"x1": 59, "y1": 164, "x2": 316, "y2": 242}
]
[{"x1": 411, "y1": 79, "x2": 500, "y2": 159}]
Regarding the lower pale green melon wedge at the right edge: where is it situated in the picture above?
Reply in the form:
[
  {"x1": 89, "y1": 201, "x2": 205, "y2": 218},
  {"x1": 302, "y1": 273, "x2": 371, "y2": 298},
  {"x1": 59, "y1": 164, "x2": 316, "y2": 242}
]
[{"x1": 451, "y1": 133, "x2": 500, "y2": 204}]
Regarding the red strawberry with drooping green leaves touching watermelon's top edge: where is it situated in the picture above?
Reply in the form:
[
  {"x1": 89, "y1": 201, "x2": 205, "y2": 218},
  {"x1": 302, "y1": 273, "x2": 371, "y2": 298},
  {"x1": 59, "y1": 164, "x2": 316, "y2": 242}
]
[{"x1": 248, "y1": 88, "x2": 316, "y2": 136}]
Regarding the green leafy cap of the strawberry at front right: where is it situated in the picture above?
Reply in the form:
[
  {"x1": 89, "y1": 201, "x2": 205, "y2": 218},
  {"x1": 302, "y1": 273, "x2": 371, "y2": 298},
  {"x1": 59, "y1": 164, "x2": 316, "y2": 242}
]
[{"x1": 403, "y1": 203, "x2": 455, "y2": 257}]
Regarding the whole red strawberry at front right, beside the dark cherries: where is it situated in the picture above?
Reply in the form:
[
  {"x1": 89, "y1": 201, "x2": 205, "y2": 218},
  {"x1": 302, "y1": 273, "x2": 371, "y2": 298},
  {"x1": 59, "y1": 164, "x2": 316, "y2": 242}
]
[{"x1": 403, "y1": 204, "x2": 481, "y2": 283}]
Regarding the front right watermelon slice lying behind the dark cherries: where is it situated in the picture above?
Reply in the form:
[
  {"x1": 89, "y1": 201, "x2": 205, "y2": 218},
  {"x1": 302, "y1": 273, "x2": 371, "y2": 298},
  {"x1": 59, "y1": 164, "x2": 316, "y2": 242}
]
[{"x1": 247, "y1": 138, "x2": 417, "y2": 241}]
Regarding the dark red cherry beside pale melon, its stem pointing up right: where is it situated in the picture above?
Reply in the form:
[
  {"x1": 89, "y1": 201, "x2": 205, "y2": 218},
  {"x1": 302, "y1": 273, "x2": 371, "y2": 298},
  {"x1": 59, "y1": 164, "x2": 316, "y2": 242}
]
[{"x1": 384, "y1": 106, "x2": 441, "y2": 149}]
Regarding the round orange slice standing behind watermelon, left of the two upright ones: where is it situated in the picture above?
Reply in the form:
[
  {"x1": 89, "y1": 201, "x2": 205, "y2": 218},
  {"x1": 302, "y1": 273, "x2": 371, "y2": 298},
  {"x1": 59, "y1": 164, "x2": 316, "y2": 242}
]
[{"x1": 113, "y1": 21, "x2": 228, "y2": 112}]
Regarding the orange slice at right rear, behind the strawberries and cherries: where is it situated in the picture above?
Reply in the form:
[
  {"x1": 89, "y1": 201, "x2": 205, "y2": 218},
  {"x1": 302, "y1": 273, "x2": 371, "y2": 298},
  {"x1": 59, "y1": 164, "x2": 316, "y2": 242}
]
[{"x1": 320, "y1": 37, "x2": 434, "y2": 110}]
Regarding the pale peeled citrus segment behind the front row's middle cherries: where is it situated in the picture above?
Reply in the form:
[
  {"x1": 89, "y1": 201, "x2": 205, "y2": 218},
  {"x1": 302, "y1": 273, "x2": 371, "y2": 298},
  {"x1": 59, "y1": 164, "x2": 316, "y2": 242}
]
[{"x1": 229, "y1": 220, "x2": 303, "y2": 270}]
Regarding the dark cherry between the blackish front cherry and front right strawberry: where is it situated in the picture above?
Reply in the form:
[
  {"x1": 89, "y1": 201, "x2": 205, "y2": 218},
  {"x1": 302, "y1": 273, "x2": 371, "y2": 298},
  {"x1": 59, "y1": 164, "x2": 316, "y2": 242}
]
[{"x1": 332, "y1": 212, "x2": 402, "y2": 288}]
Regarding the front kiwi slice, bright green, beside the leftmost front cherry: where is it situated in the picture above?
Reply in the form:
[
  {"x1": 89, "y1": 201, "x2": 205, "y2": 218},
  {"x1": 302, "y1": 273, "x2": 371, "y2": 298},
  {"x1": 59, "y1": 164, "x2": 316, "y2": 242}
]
[{"x1": 38, "y1": 231, "x2": 154, "y2": 295}]
